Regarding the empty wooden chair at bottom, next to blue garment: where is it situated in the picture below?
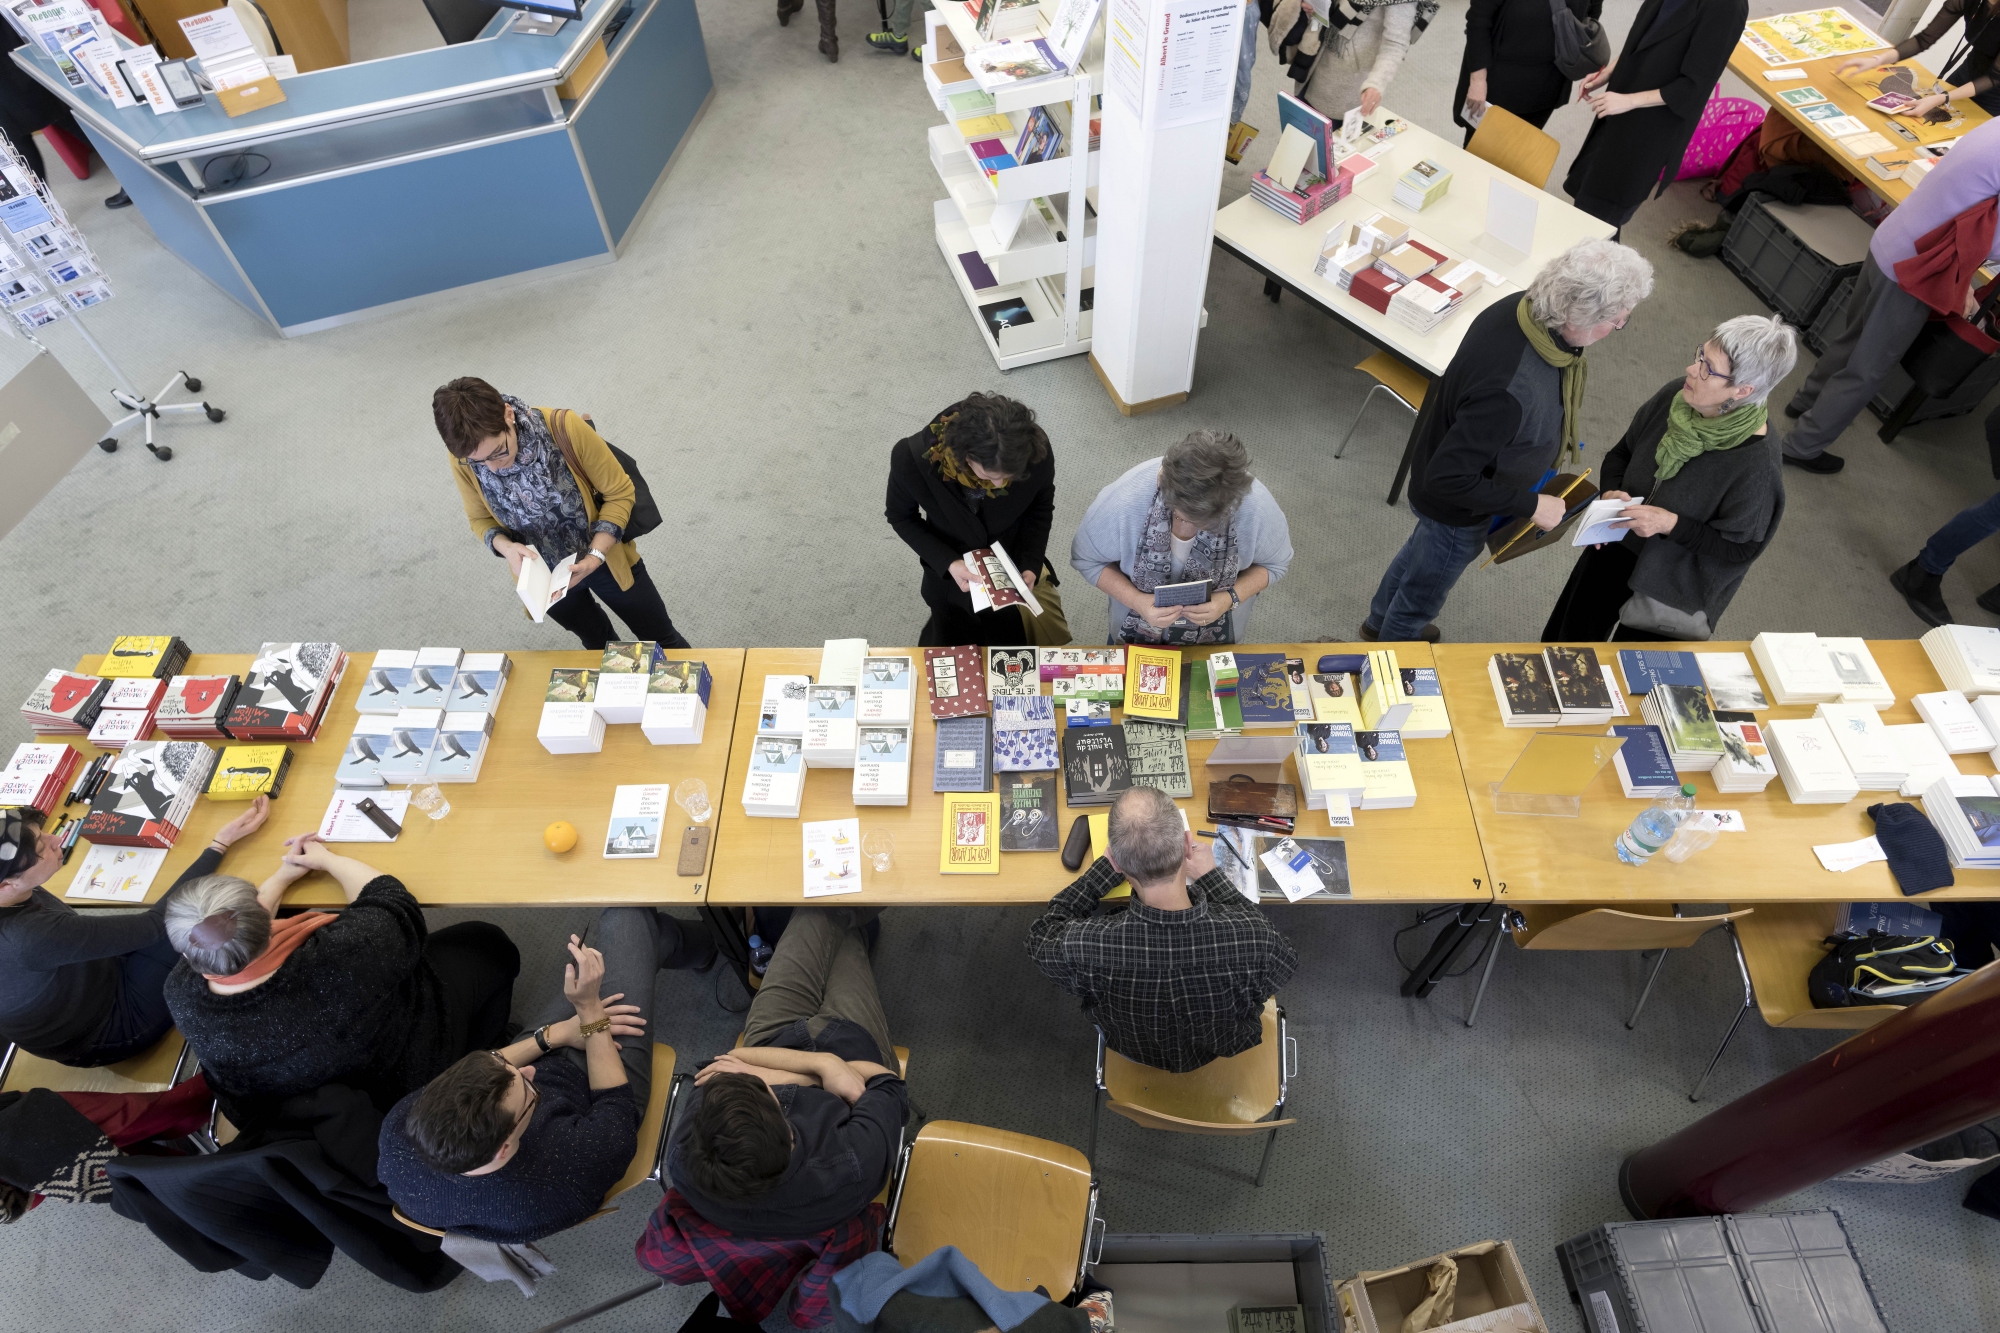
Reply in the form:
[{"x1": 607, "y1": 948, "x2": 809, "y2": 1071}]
[{"x1": 882, "y1": 1121, "x2": 1098, "y2": 1301}]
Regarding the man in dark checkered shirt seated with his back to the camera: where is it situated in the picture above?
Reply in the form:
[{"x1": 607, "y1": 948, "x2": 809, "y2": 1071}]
[{"x1": 1028, "y1": 787, "x2": 1298, "y2": 1073}]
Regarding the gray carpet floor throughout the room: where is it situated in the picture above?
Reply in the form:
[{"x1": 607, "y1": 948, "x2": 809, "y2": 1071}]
[{"x1": 0, "y1": 0, "x2": 2000, "y2": 1333}]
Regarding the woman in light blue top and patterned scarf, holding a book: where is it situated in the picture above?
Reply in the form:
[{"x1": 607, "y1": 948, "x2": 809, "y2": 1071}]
[{"x1": 1070, "y1": 430, "x2": 1292, "y2": 644}]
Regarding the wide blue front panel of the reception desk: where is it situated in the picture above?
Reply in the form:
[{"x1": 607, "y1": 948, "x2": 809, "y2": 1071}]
[{"x1": 204, "y1": 126, "x2": 608, "y2": 328}]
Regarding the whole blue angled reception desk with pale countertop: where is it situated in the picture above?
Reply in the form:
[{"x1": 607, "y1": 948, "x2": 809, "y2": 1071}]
[{"x1": 14, "y1": 0, "x2": 714, "y2": 336}]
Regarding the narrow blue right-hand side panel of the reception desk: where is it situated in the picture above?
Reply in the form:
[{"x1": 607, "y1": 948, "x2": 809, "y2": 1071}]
[{"x1": 572, "y1": 0, "x2": 714, "y2": 244}]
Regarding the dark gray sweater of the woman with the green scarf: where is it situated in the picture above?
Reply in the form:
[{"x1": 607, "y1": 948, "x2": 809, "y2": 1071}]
[{"x1": 1604, "y1": 378, "x2": 1784, "y2": 630}]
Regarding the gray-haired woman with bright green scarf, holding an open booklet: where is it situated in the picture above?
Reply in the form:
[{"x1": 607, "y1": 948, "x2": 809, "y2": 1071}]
[{"x1": 1542, "y1": 314, "x2": 1798, "y2": 642}]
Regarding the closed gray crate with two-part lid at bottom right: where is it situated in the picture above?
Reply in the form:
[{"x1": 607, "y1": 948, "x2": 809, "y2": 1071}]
[{"x1": 1556, "y1": 1209, "x2": 1888, "y2": 1333}]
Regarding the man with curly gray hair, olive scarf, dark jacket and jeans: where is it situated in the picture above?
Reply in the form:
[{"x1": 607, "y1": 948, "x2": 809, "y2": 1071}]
[{"x1": 1362, "y1": 240, "x2": 1652, "y2": 642}]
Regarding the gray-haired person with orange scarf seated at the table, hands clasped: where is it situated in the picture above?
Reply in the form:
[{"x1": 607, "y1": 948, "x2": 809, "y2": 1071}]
[{"x1": 166, "y1": 833, "x2": 520, "y2": 1127}]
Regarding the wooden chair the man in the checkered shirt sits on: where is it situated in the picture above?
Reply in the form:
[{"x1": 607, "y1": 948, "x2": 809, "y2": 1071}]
[{"x1": 1090, "y1": 997, "x2": 1298, "y2": 1185}]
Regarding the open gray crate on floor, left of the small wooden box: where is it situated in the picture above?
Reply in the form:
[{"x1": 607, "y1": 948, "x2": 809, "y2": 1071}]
[{"x1": 1092, "y1": 1231, "x2": 1340, "y2": 1333}]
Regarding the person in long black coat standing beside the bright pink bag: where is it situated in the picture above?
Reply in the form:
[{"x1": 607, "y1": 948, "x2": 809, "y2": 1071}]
[{"x1": 1562, "y1": 0, "x2": 1748, "y2": 228}]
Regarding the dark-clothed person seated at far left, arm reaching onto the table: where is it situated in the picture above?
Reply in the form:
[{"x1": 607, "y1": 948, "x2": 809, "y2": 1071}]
[{"x1": 0, "y1": 797, "x2": 270, "y2": 1067}]
